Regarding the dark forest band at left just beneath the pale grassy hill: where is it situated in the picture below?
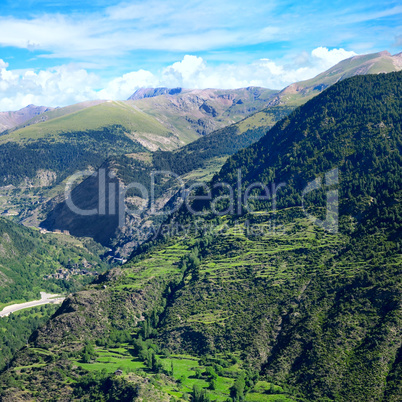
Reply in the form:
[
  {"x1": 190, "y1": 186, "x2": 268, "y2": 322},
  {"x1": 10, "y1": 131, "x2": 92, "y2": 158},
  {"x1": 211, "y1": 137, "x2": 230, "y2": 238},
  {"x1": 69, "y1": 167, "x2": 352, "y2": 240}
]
[{"x1": 0, "y1": 125, "x2": 146, "y2": 185}]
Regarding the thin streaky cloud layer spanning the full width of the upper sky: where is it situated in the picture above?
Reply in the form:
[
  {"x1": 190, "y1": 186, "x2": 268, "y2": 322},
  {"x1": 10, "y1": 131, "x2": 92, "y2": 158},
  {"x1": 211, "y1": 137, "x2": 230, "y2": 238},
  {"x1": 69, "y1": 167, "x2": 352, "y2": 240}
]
[{"x1": 0, "y1": 0, "x2": 396, "y2": 66}]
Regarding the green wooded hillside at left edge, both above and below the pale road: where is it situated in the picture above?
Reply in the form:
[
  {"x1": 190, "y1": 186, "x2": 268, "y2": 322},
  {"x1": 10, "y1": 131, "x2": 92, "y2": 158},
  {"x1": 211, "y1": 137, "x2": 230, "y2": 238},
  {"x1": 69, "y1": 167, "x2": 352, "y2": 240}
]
[{"x1": 0, "y1": 218, "x2": 110, "y2": 374}]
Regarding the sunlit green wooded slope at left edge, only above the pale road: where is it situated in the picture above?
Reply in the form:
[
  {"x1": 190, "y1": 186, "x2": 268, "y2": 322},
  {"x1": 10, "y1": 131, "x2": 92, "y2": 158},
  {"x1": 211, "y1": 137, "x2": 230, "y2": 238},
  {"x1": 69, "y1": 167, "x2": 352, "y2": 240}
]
[{"x1": 0, "y1": 218, "x2": 109, "y2": 306}]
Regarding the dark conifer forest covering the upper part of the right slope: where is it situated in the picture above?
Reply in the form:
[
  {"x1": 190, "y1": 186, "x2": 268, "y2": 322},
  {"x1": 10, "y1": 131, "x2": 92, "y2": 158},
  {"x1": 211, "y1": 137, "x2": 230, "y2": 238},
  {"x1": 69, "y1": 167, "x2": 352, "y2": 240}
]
[{"x1": 212, "y1": 73, "x2": 402, "y2": 223}]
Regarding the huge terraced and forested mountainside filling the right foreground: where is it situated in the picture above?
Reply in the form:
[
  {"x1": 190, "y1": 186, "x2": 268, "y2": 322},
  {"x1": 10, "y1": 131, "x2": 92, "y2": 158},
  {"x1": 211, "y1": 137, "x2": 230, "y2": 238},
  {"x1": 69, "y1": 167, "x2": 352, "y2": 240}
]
[{"x1": 0, "y1": 73, "x2": 402, "y2": 402}]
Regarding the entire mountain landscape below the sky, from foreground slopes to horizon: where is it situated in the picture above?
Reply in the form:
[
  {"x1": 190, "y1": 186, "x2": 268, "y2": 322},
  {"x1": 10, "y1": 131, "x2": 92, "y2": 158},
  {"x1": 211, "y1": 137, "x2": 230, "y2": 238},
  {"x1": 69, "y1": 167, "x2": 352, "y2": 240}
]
[{"x1": 0, "y1": 52, "x2": 402, "y2": 402}]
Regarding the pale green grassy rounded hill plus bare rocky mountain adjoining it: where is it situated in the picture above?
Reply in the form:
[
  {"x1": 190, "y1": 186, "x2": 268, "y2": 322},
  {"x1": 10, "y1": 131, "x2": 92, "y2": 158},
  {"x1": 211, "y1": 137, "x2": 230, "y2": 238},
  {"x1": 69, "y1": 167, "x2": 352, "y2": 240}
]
[{"x1": 0, "y1": 88, "x2": 276, "y2": 151}]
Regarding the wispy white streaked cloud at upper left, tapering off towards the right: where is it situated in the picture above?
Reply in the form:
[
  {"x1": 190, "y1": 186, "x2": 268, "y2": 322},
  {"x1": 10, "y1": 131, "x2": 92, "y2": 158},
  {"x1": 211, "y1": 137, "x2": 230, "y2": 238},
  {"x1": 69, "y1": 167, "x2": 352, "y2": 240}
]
[{"x1": 0, "y1": 0, "x2": 277, "y2": 61}]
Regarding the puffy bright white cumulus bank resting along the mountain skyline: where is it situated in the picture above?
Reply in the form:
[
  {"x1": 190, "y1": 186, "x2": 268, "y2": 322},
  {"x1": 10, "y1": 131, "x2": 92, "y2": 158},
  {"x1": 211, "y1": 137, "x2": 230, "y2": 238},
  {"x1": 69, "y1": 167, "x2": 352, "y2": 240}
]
[{"x1": 0, "y1": 47, "x2": 356, "y2": 110}]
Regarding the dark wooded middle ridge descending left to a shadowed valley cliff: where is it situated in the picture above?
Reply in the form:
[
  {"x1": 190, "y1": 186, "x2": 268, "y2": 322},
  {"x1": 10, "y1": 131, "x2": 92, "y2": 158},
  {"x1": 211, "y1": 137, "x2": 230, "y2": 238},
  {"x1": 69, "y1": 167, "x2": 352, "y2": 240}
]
[{"x1": 41, "y1": 106, "x2": 293, "y2": 255}]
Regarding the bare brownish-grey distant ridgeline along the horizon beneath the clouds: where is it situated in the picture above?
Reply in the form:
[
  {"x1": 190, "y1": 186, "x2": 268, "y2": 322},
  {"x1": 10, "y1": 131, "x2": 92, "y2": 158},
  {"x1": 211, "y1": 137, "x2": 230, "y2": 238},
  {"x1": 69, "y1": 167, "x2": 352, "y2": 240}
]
[{"x1": 0, "y1": 51, "x2": 402, "y2": 142}]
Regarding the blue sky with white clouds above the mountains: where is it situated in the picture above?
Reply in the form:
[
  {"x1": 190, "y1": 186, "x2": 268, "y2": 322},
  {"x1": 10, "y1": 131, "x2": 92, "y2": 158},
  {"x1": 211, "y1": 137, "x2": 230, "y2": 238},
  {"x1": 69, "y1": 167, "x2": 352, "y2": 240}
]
[{"x1": 0, "y1": 0, "x2": 402, "y2": 110}]
